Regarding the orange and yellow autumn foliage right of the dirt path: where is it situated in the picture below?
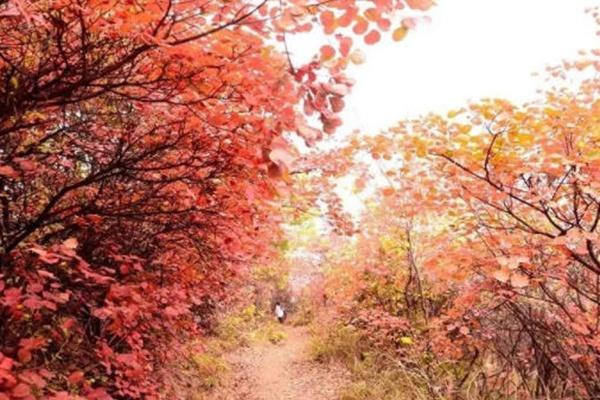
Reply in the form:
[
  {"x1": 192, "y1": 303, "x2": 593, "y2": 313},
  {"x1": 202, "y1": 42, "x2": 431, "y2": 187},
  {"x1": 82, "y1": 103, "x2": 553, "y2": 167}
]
[{"x1": 300, "y1": 22, "x2": 600, "y2": 399}]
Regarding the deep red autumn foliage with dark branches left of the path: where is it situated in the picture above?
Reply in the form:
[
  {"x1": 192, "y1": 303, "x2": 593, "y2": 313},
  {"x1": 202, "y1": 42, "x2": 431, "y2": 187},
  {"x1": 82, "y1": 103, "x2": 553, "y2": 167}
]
[{"x1": 0, "y1": 0, "x2": 431, "y2": 399}]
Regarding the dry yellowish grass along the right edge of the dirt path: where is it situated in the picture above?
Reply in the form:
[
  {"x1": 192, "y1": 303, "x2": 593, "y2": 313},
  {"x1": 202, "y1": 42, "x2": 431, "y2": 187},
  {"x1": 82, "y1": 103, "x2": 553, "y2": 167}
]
[{"x1": 310, "y1": 324, "x2": 492, "y2": 400}]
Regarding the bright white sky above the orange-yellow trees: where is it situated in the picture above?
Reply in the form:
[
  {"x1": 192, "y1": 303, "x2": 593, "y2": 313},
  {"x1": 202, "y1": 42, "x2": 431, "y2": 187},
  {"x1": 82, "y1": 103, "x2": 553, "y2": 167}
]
[{"x1": 291, "y1": 0, "x2": 600, "y2": 133}]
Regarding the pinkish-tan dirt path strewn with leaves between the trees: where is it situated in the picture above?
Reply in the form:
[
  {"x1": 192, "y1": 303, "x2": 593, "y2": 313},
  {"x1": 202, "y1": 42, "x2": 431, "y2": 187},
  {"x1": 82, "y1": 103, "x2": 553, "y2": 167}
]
[{"x1": 215, "y1": 326, "x2": 348, "y2": 400}]
